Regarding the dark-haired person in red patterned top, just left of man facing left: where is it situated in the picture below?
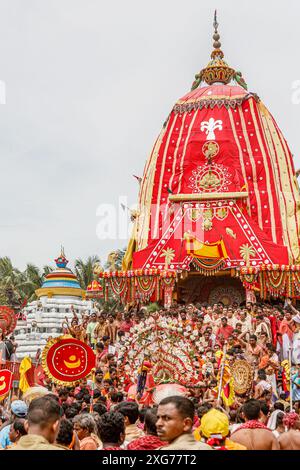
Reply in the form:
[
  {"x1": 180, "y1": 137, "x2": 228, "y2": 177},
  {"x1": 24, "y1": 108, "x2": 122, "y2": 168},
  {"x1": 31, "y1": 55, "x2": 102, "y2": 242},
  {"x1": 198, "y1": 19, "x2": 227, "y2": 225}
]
[{"x1": 127, "y1": 408, "x2": 165, "y2": 450}]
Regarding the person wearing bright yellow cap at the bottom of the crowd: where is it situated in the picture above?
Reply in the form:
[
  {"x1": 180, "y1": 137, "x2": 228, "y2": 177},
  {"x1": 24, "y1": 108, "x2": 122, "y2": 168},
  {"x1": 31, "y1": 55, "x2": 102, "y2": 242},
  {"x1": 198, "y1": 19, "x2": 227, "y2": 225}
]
[{"x1": 194, "y1": 408, "x2": 247, "y2": 450}]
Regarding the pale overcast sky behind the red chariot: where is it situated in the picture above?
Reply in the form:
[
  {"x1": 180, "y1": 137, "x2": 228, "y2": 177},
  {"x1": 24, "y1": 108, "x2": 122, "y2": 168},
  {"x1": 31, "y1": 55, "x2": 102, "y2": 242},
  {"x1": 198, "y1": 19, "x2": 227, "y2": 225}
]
[{"x1": 0, "y1": 0, "x2": 300, "y2": 269}]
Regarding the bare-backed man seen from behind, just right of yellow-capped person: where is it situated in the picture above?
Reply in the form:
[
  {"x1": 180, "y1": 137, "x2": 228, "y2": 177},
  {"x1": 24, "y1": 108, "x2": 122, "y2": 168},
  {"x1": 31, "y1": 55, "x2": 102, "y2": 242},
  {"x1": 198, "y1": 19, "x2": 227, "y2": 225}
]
[{"x1": 230, "y1": 399, "x2": 279, "y2": 450}]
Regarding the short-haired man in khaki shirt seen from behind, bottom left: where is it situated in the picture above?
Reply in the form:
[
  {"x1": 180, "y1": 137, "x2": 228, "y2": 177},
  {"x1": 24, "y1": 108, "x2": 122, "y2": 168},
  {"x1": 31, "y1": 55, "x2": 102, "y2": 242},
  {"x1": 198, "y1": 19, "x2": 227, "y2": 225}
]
[{"x1": 8, "y1": 396, "x2": 63, "y2": 450}]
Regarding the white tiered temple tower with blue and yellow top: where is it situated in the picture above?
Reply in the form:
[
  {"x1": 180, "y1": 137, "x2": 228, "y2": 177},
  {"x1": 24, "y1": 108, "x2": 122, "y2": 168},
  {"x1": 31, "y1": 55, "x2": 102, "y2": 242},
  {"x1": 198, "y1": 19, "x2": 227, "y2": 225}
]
[{"x1": 14, "y1": 250, "x2": 93, "y2": 360}]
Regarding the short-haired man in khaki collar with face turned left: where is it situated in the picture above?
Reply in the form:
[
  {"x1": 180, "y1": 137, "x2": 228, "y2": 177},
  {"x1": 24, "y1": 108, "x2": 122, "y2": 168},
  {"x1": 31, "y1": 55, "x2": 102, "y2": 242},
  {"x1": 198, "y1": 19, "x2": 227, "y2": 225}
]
[{"x1": 156, "y1": 396, "x2": 211, "y2": 450}]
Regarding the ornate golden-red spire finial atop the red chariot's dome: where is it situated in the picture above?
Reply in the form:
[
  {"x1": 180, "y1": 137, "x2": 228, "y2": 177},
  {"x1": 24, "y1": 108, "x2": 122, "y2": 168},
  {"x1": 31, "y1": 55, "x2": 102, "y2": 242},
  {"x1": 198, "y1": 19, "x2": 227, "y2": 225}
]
[{"x1": 192, "y1": 10, "x2": 247, "y2": 90}]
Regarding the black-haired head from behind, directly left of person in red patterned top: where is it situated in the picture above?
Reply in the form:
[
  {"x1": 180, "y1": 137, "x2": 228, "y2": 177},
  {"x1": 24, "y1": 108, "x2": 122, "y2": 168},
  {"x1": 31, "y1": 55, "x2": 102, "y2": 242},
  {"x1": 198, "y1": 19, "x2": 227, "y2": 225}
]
[{"x1": 99, "y1": 411, "x2": 125, "y2": 450}]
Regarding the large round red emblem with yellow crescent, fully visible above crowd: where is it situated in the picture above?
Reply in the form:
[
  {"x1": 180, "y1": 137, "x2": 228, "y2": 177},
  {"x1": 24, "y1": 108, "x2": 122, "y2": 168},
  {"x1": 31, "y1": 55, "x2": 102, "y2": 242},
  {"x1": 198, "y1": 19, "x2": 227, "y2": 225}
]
[{"x1": 43, "y1": 336, "x2": 96, "y2": 383}]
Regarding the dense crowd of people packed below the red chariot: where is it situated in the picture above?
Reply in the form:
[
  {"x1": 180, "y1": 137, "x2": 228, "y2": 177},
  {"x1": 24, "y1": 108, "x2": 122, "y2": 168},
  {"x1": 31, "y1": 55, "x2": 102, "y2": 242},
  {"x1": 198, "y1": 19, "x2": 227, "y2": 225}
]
[{"x1": 0, "y1": 301, "x2": 300, "y2": 450}]
